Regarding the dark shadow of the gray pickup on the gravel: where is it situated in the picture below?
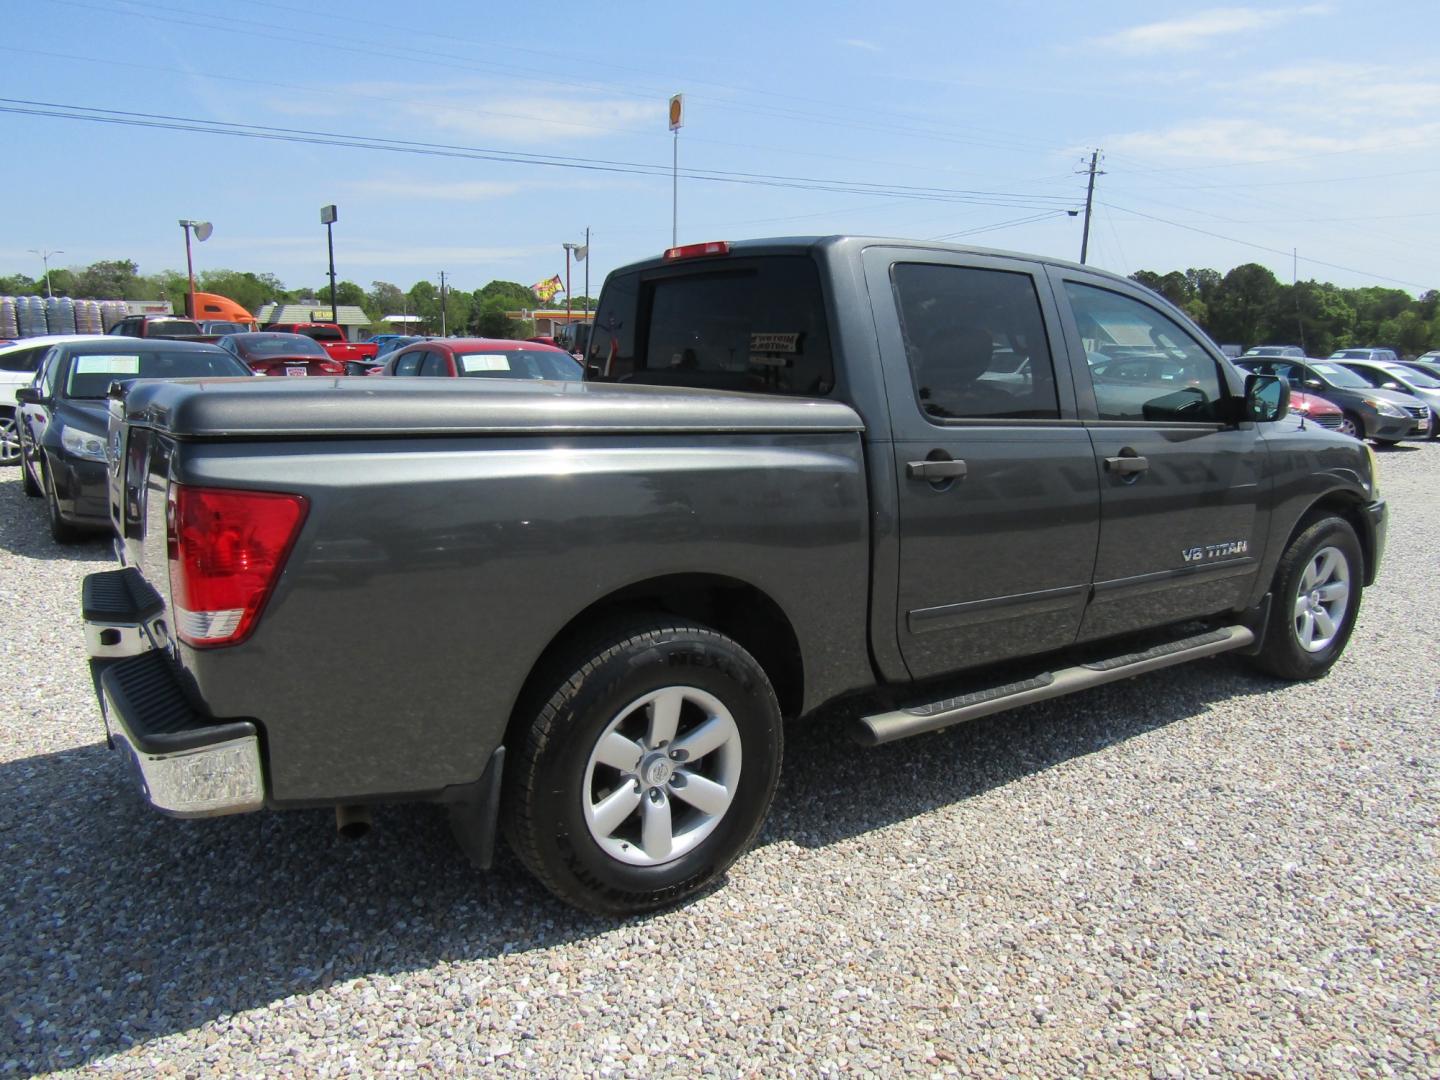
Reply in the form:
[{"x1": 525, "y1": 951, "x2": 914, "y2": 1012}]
[{"x1": 0, "y1": 660, "x2": 1280, "y2": 1073}]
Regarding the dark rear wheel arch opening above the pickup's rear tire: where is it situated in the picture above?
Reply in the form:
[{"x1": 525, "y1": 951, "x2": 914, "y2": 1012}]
[{"x1": 505, "y1": 573, "x2": 805, "y2": 743}]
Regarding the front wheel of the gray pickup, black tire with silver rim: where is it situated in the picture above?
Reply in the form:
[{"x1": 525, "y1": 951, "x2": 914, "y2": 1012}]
[{"x1": 1254, "y1": 516, "x2": 1365, "y2": 680}]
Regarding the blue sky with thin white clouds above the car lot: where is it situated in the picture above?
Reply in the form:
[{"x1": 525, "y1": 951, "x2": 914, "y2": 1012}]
[{"x1": 0, "y1": 0, "x2": 1440, "y2": 294}]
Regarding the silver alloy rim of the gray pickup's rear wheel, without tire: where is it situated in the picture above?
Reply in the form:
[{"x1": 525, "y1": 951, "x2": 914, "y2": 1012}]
[{"x1": 580, "y1": 687, "x2": 740, "y2": 867}]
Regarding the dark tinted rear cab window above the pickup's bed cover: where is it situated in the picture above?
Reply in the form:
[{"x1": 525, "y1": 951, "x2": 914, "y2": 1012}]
[{"x1": 586, "y1": 255, "x2": 835, "y2": 397}]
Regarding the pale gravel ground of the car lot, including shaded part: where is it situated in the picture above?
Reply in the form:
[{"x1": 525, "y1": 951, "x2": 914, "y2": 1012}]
[{"x1": 0, "y1": 445, "x2": 1440, "y2": 1077}]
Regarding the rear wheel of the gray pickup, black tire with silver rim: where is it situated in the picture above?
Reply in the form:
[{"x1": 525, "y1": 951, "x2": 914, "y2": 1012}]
[{"x1": 503, "y1": 618, "x2": 783, "y2": 916}]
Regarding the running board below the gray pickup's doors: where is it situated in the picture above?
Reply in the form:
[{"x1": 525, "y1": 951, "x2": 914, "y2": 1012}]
[{"x1": 852, "y1": 626, "x2": 1256, "y2": 746}]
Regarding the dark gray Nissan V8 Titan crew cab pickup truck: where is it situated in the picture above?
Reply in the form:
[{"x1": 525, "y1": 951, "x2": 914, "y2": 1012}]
[{"x1": 84, "y1": 238, "x2": 1385, "y2": 913}]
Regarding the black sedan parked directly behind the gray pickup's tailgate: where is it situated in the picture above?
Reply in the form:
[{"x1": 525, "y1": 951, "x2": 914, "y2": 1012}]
[{"x1": 16, "y1": 337, "x2": 251, "y2": 543}]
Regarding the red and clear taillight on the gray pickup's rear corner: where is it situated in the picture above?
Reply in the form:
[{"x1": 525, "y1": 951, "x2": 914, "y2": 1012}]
[{"x1": 166, "y1": 484, "x2": 308, "y2": 648}]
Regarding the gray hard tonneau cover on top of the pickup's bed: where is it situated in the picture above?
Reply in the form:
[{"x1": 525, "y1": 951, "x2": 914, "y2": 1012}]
[{"x1": 125, "y1": 376, "x2": 864, "y2": 439}]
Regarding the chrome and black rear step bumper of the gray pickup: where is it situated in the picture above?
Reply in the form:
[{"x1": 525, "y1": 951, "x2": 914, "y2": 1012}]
[{"x1": 81, "y1": 569, "x2": 265, "y2": 818}]
